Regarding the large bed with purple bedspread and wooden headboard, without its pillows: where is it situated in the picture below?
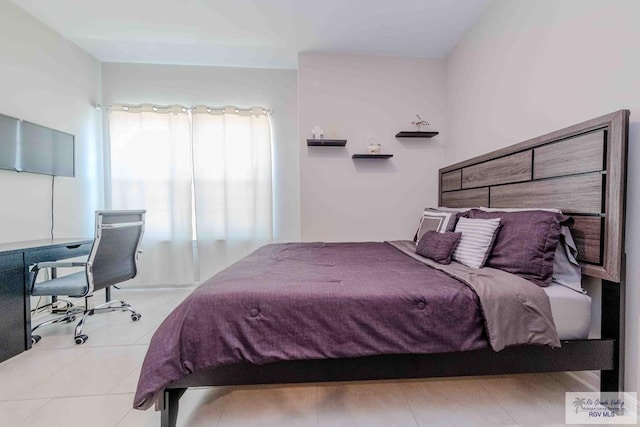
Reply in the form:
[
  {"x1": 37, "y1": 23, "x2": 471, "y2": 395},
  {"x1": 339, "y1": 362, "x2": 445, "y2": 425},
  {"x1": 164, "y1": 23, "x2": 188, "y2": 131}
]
[{"x1": 134, "y1": 110, "x2": 629, "y2": 426}]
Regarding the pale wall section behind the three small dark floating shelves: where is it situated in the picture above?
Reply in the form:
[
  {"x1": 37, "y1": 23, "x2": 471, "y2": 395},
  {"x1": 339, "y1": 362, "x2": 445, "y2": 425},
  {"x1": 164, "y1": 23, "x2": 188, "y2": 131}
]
[{"x1": 298, "y1": 54, "x2": 446, "y2": 241}]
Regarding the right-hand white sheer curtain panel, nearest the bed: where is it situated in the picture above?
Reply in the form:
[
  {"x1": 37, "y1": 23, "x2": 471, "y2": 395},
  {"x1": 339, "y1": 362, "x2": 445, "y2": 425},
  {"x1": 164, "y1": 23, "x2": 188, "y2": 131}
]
[{"x1": 193, "y1": 107, "x2": 273, "y2": 280}]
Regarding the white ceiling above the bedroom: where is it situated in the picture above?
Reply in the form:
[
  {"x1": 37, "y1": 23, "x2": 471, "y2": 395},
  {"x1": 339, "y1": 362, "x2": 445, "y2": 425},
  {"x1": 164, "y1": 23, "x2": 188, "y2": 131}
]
[{"x1": 12, "y1": 0, "x2": 489, "y2": 68}]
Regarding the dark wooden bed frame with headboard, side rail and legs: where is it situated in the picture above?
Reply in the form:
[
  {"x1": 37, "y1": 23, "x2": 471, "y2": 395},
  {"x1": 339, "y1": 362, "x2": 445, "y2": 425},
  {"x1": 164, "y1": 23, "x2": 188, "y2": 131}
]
[{"x1": 159, "y1": 110, "x2": 629, "y2": 427}]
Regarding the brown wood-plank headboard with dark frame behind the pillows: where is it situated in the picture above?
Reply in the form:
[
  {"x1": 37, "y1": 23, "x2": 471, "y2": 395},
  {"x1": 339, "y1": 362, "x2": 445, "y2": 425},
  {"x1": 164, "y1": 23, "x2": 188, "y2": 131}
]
[{"x1": 438, "y1": 110, "x2": 629, "y2": 282}]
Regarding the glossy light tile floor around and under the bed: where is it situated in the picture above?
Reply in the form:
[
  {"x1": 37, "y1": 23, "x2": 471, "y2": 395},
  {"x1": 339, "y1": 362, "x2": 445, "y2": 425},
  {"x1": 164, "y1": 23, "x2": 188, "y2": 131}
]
[{"x1": 0, "y1": 289, "x2": 587, "y2": 427}]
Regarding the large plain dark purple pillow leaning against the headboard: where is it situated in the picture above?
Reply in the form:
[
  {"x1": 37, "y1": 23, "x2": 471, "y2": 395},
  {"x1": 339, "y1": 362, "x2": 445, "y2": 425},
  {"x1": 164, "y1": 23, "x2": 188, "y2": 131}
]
[{"x1": 469, "y1": 209, "x2": 572, "y2": 286}]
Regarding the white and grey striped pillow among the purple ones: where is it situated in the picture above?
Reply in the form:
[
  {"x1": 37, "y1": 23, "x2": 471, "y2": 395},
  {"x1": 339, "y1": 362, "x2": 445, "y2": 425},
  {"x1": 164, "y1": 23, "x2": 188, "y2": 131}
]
[{"x1": 453, "y1": 218, "x2": 500, "y2": 268}]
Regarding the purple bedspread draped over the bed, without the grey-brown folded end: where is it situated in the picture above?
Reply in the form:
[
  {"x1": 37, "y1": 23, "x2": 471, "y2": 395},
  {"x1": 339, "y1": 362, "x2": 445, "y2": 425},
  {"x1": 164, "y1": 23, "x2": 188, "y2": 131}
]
[{"x1": 134, "y1": 243, "x2": 488, "y2": 409}]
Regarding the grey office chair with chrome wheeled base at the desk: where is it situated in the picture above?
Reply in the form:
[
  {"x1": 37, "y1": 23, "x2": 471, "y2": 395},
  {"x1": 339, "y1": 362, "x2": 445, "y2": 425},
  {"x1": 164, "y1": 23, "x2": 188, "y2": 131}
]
[{"x1": 31, "y1": 210, "x2": 146, "y2": 344}]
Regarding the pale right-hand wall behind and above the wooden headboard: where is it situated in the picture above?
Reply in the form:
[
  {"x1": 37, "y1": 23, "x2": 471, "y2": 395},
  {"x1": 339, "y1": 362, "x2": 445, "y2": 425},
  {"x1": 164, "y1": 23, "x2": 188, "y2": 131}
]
[{"x1": 445, "y1": 0, "x2": 640, "y2": 391}]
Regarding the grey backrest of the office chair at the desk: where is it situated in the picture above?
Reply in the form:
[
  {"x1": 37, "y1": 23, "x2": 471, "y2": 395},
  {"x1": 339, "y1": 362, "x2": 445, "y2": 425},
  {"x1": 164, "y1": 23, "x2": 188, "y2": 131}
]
[{"x1": 87, "y1": 210, "x2": 146, "y2": 292}]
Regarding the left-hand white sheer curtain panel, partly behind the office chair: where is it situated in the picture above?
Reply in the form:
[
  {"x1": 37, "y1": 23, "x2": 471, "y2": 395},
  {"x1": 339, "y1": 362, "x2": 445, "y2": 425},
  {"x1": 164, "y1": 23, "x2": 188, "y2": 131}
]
[{"x1": 109, "y1": 105, "x2": 194, "y2": 285}]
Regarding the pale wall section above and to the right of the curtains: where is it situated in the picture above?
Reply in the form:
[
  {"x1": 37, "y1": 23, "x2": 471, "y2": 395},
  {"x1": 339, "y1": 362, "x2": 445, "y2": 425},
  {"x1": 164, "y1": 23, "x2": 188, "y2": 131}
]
[{"x1": 102, "y1": 63, "x2": 300, "y2": 242}]
